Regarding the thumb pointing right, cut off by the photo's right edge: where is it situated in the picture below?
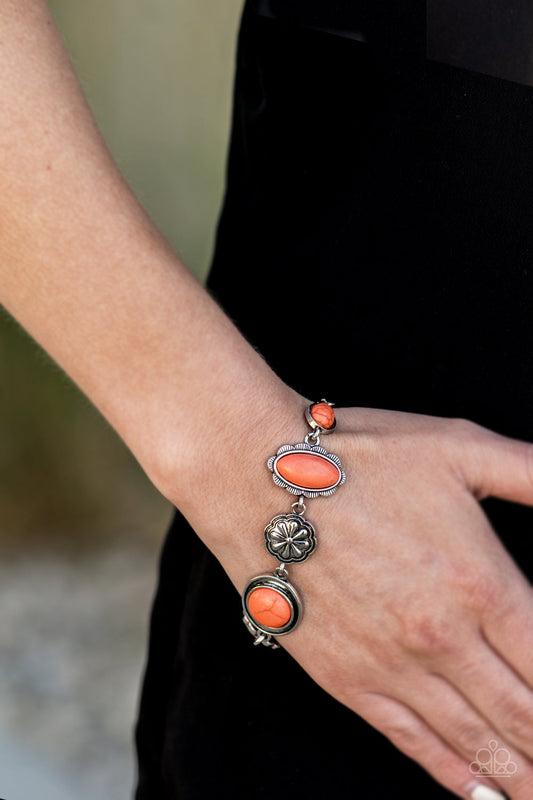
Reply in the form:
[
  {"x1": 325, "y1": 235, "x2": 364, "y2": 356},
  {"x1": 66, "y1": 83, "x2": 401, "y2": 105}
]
[{"x1": 460, "y1": 423, "x2": 533, "y2": 505}]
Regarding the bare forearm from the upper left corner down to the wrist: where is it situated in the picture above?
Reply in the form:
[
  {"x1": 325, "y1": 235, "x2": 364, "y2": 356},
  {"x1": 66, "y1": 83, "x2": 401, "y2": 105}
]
[{"x1": 0, "y1": 0, "x2": 302, "y2": 510}]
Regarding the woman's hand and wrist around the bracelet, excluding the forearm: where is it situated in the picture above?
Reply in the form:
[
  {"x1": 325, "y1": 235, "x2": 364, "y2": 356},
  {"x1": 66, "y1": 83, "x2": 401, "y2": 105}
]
[{"x1": 176, "y1": 398, "x2": 533, "y2": 800}]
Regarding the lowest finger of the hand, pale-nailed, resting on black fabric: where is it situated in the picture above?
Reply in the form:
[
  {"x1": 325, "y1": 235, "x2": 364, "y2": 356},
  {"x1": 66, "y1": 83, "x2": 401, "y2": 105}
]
[{"x1": 354, "y1": 692, "x2": 504, "y2": 800}]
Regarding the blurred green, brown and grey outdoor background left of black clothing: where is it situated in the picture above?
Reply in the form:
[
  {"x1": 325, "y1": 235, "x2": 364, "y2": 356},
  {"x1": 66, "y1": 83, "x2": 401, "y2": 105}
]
[{"x1": 0, "y1": 0, "x2": 242, "y2": 800}]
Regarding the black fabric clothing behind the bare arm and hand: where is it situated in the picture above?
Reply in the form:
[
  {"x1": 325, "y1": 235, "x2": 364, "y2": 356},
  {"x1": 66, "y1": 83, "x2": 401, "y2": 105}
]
[{"x1": 137, "y1": 0, "x2": 533, "y2": 800}]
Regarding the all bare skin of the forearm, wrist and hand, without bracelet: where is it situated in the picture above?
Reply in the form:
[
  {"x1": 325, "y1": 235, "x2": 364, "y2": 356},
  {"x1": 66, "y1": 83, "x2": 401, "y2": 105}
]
[{"x1": 0, "y1": 0, "x2": 533, "y2": 800}]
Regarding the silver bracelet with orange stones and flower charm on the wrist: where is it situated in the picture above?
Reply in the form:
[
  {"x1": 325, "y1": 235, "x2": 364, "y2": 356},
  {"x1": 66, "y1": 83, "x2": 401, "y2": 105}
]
[{"x1": 242, "y1": 400, "x2": 346, "y2": 650}]
